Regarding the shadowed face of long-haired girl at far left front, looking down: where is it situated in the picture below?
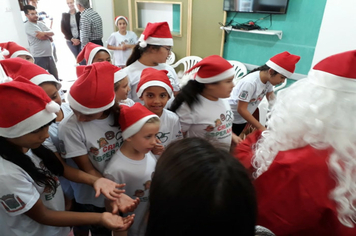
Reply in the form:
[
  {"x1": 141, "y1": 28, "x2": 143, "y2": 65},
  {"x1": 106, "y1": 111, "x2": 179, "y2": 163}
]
[{"x1": 7, "y1": 125, "x2": 49, "y2": 149}]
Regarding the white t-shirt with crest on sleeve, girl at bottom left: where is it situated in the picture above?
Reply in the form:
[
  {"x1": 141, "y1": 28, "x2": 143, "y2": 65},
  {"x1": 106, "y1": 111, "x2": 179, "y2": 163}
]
[{"x1": 0, "y1": 150, "x2": 69, "y2": 236}]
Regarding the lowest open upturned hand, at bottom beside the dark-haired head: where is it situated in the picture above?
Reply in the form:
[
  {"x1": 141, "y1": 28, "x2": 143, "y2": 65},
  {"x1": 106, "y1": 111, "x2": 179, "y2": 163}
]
[{"x1": 100, "y1": 212, "x2": 135, "y2": 231}]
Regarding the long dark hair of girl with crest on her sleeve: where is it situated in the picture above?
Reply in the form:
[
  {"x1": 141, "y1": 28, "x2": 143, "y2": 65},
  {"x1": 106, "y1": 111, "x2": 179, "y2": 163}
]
[{"x1": 0, "y1": 122, "x2": 64, "y2": 193}]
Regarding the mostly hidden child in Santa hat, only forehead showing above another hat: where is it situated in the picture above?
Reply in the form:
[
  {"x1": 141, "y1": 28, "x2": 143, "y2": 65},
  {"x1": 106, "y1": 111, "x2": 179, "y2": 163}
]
[{"x1": 77, "y1": 42, "x2": 112, "y2": 65}]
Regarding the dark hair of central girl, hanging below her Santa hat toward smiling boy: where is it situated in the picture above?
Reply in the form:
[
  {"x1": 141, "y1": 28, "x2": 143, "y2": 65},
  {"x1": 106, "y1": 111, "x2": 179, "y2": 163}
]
[{"x1": 170, "y1": 80, "x2": 205, "y2": 112}]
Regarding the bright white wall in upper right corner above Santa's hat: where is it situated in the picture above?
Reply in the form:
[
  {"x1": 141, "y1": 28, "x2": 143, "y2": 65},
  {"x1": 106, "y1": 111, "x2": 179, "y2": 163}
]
[{"x1": 312, "y1": 0, "x2": 356, "y2": 66}]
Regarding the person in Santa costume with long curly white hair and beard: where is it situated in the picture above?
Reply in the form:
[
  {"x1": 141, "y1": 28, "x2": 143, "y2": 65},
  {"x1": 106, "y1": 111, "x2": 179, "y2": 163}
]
[{"x1": 236, "y1": 50, "x2": 356, "y2": 236}]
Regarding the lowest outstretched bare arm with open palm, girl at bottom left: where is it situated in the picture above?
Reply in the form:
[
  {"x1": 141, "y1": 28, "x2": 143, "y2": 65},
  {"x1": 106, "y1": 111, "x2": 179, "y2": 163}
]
[{"x1": 25, "y1": 199, "x2": 133, "y2": 230}]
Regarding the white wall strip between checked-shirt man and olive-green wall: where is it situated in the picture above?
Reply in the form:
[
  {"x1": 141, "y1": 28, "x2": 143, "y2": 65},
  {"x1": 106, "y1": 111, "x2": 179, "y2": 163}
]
[{"x1": 92, "y1": 0, "x2": 116, "y2": 47}]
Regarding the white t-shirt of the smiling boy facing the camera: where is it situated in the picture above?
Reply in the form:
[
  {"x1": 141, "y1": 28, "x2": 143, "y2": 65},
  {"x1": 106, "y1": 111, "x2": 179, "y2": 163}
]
[{"x1": 155, "y1": 109, "x2": 183, "y2": 158}]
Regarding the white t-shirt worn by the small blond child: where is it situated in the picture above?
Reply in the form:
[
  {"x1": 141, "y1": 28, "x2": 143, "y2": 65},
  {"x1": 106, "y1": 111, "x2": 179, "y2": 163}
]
[{"x1": 104, "y1": 150, "x2": 156, "y2": 236}]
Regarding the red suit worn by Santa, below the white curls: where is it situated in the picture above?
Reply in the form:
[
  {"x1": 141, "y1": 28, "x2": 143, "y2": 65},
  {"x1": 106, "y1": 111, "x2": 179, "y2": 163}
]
[{"x1": 235, "y1": 131, "x2": 356, "y2": 236}]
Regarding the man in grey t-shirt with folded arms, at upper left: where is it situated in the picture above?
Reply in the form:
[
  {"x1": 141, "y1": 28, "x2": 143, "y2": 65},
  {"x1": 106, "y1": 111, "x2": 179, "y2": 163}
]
[{"x1": 24, "y1": 5, "x2": 58, "y2": 80}]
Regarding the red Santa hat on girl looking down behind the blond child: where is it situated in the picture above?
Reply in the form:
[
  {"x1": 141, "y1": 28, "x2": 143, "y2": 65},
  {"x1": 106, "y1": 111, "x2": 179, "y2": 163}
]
[{"x1": 68, "y1": 61, "x2": 116, "y2": 115}]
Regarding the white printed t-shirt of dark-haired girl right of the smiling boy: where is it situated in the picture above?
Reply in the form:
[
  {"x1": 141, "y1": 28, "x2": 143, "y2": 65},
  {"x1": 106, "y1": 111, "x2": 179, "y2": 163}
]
[{"x1": 176, "y1": 94, "x2": 234, "y2": 149}]
